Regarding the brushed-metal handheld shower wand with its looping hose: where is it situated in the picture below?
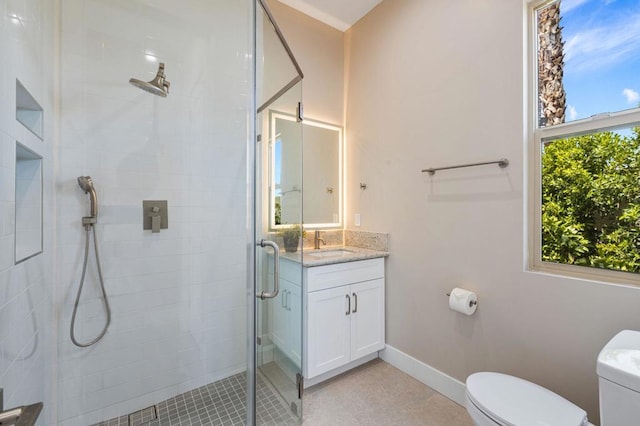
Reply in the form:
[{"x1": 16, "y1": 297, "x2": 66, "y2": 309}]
[{"x1": 69, "y1": 176, "x2": 111, "y2": 348}]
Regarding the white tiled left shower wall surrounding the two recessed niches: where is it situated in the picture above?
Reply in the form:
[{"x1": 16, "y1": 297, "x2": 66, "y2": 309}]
[{"x1": 0, "y1": 0, "x2": 55, "y2": 424}]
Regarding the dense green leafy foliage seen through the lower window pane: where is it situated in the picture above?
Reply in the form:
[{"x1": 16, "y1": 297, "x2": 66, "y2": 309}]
[{"x1": 542, "y1": 128, "x2": 640, "y2": 272}]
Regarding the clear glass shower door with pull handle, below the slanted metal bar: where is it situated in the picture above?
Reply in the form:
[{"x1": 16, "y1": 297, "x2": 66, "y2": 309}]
[{"x1": 256, "y1": 85, "x2": 303, "y2": 424}]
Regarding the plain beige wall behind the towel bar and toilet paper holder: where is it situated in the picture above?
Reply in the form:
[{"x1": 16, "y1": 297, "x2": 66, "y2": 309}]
[{"x1": 345, "y1": 0, "x2": 640, "y2": 422}]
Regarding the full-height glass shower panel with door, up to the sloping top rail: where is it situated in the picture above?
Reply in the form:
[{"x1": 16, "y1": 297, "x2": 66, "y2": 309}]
[{"x1": 255, "y1": 0, "x2": 304, "y2": 425}]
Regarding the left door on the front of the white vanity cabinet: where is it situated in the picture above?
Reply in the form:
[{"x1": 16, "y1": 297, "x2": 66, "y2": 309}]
[{"x1": 307, "y1": 286, "x2": 351, "y2": 377}]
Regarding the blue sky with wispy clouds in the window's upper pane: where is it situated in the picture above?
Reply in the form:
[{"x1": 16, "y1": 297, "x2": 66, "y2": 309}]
[{"x1": 560, "y1": 0, "x2": 640, "y2": 121}]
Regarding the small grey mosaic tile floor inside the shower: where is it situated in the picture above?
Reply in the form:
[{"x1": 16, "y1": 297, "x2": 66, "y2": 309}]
[{"x1": 94, "y1": 373, "x2": 299, "y2": 426}]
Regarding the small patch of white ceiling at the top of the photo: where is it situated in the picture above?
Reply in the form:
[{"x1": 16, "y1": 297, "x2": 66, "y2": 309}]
[{"x1": 280, "y1": 0, "x2": 382, "y2": 31}]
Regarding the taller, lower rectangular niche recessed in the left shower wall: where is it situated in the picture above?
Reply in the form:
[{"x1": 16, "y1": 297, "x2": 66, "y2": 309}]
[{"x1": 15, "y1": 142, "x2": 42, "y2": 264}]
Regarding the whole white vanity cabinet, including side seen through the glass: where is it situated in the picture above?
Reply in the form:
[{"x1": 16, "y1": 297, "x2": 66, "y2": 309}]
[{"x1": 269, "y1": 257, "x2": 385, "y2": 381}]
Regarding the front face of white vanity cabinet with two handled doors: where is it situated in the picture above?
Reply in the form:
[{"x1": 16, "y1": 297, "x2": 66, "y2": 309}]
[{"x1": 304, "y1": 258, "x2": 385, "y2": 379}]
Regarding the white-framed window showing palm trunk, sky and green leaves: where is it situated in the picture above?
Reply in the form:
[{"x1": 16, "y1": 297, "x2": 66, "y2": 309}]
[{"x1": 529, "y1": 0, "x2": 640, "y2": 284}]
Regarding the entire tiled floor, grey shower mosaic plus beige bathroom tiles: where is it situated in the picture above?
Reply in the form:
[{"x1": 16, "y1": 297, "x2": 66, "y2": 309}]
[{"x1": 94, "y1": 360, "x2": 473, "y2": 426}]
